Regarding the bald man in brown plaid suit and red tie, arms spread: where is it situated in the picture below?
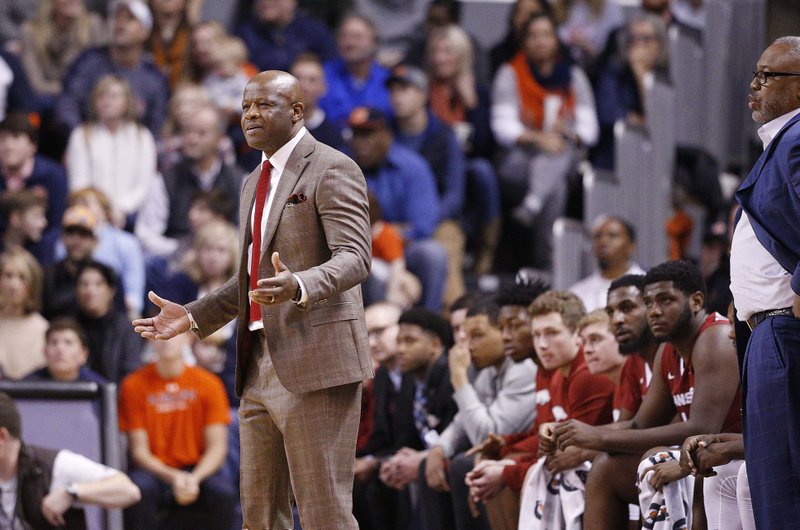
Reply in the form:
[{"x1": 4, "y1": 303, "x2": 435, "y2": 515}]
[{"x1": 133, "y1": 70, "x2": 373, "y2": 530}]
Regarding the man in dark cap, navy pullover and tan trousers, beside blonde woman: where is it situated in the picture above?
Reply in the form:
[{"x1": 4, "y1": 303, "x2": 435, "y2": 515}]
[{"x1": 386, "y1": 64, "x2": 466, "y2": 304}]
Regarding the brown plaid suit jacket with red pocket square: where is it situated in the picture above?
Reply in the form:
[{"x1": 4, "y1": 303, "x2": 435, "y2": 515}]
[{"x1": 186, "y1": 132, "x2": 373, "y2": 395}]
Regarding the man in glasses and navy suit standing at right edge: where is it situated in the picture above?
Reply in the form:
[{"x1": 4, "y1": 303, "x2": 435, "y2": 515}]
[{"x1": 731, "y1": 37, "x2": 800, "y2": 529}]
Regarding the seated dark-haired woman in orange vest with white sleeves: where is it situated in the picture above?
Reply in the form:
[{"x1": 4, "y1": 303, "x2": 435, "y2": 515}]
[{"x1": 491, "y1": 14, "x2": 598, "y2": 270}]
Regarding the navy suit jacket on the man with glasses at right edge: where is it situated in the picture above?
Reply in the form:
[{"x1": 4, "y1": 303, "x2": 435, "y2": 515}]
[{"x1": 736, "y1": 114, "x2": 800, "y2": 294}]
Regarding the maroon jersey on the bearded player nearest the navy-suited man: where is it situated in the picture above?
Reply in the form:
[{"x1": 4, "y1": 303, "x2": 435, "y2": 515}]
[{"x1": 661, "y1": 313, "x2": 742, "y2": 433}]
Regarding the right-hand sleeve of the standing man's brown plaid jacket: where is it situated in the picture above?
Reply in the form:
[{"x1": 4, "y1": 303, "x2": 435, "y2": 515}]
[{"x1": 295, "y1": 151, "x2": 372, "y2": 303}]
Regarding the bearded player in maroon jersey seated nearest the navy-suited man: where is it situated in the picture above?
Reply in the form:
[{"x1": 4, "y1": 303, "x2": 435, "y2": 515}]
[{"x1": 552, "y1": 261, "x2": 741, "y2": 530}]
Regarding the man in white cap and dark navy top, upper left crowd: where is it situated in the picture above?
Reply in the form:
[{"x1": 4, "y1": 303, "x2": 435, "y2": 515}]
[{"x1": 56, "y1": 0, "x2": 169, "y2": 137}]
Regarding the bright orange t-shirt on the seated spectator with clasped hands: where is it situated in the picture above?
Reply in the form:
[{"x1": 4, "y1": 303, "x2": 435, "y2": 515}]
[{"x1": 119, "y1": 364, "x2": 231, "y2": 468}]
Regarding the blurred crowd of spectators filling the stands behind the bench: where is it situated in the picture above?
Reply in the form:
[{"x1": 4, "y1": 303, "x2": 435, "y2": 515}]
[{"x1": 0, "y1": 0, "x2": 800, "y2": 528}]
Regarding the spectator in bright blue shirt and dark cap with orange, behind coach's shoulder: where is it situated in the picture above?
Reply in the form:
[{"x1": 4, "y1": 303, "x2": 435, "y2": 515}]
[{"x1": 349, "y1": 107, "x2": 447, "y2": 310}]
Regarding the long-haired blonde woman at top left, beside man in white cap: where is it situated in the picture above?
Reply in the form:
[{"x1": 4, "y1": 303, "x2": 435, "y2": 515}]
[{"x1": 21, "y1": 0, "x2": 106, "y2": 98}]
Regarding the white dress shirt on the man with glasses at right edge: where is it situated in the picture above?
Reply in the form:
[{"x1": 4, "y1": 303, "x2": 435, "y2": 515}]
[{"x1": 731, "y1": 109, "x2": 800, "y2": 322}]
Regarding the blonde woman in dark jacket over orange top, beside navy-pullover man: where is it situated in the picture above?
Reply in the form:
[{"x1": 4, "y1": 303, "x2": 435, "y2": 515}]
[{"x1": 427, "y1": 25, "x2": 500, "y2": 274}]
